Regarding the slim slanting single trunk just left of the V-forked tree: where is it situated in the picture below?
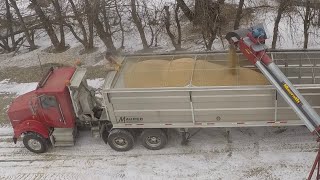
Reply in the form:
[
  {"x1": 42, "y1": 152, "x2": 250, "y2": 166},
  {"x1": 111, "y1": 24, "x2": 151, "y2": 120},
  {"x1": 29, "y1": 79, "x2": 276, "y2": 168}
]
[{"x1": 131, "y1": 0, "x2": 149, "y2": 49}]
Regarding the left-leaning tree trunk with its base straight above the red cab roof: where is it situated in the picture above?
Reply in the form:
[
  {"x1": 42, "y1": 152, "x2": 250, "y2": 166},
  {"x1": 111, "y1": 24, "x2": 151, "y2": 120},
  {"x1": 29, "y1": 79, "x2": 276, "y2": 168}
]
[{"x1": 30, "y1": 0, "x2": 61, "y2": 50}]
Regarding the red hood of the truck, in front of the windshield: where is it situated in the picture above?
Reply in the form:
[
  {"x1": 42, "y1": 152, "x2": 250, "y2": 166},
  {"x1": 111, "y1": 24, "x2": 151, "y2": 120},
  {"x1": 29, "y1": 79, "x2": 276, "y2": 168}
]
[{"x1": 7, "y1": 91, "x2": 35, "y2": 127}]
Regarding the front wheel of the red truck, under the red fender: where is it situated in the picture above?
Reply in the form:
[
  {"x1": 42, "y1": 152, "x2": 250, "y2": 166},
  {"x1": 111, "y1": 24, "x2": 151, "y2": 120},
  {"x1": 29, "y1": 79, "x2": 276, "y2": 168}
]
[{"x1": 23, "y1": 132, "x2": 49, "y2": 153}]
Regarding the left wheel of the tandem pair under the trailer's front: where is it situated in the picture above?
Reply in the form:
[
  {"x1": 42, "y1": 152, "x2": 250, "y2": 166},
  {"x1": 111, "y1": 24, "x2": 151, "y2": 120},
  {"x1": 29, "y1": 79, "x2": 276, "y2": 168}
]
[{"x1": 108, "y1": 129, "x2": 134, "y2": 151}]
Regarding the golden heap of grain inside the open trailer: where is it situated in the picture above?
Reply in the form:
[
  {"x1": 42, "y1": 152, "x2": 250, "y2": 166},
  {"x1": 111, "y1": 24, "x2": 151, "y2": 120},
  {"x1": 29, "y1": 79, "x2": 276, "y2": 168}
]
[{"x1": 124, "y1": 58, "x2": 268, "y2": 88}]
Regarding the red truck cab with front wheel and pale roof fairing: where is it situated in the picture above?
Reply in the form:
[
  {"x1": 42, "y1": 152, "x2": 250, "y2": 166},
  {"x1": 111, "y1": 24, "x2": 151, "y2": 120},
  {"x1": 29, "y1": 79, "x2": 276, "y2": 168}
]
[{"x1": 8, "y1": 67, "x2": 106, "y2": 153}]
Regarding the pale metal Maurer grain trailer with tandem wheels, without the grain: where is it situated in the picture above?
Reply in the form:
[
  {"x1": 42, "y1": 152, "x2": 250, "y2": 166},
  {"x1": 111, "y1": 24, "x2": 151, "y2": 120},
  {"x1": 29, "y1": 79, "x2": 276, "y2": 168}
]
[{"x1": 102, "y1": 51, "x2": 320, "y2": 151}]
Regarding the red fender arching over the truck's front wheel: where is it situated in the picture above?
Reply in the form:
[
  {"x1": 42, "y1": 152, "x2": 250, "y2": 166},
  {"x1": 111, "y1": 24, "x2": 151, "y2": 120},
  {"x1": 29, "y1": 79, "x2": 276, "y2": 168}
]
[{"x1": 13, "y1": 120, "x2": 49, "y2": 138}]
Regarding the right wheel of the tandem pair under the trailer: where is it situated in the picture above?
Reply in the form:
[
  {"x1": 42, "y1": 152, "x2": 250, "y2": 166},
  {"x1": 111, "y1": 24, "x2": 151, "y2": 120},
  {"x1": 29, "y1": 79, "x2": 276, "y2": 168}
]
[{"x1": 141, "y1": 129, "x2": 168, "y2": 150}]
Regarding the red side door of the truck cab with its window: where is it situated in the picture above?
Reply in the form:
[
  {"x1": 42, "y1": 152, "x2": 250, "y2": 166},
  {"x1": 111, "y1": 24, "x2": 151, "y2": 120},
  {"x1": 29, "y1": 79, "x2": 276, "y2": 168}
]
[{"x1": 39, "y1": 95, "x2": 66, "y2": 127}]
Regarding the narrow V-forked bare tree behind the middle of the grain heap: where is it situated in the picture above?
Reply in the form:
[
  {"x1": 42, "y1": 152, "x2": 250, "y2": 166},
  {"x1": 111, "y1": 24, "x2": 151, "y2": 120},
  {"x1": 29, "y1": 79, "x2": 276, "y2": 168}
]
[{"x1": 164, "y1": 6, "x2": 181, "y2": 50}]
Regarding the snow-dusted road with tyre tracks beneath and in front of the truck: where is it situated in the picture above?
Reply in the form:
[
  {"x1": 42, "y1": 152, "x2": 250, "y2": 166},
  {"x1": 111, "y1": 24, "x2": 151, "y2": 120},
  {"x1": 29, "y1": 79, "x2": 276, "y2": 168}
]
[{"x1": 0, "y1": 126, "x2": 317, "y2": 180}]
